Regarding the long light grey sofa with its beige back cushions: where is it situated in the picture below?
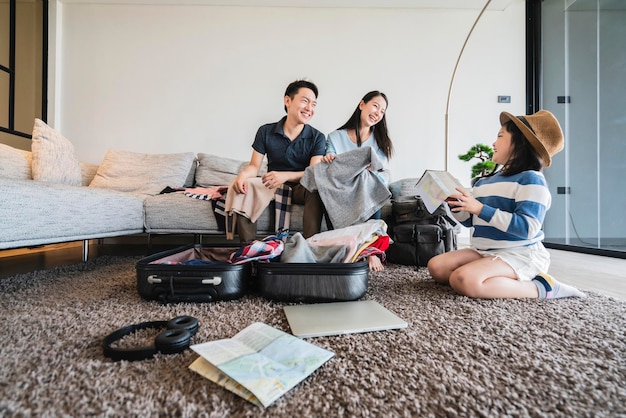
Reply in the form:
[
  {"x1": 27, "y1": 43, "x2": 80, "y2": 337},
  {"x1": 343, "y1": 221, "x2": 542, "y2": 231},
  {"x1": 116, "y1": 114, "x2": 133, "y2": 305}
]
[{"x1": 0, "y1": 120, "x2": 410, "y2": 260}]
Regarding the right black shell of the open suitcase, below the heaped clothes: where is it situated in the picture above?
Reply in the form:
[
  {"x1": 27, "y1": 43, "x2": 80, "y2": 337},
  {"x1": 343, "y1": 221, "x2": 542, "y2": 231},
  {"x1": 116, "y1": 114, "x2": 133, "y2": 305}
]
[{"x1": 255, "y1": 261, "x2": 369, "y2": 303}]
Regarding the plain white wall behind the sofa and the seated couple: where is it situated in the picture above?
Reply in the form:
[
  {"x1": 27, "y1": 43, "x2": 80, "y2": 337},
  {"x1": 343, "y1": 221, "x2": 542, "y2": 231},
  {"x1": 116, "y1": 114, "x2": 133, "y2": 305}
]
[{"x1": 49, "y1": 0, "x2": 525, "y2": 183}]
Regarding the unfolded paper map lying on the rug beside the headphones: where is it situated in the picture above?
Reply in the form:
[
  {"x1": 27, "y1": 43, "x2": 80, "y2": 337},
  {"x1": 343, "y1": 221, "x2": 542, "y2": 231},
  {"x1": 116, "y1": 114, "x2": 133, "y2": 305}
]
[{"x1": 189, "y1": 322, "x2": 335, "y2": 407}]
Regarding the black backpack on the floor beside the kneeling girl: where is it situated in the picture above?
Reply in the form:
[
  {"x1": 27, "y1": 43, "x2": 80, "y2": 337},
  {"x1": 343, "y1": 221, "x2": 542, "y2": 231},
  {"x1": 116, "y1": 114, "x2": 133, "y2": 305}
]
[{"x1": 386, "y1": 196, "x2": 461, "y2": 267}]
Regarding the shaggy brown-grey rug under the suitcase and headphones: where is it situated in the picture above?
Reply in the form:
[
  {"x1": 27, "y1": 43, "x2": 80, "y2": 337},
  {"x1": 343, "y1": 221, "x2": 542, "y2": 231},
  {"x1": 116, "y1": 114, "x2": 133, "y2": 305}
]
[{"x1": 0, "y1": 256, "x2": 626, "y2": 418}]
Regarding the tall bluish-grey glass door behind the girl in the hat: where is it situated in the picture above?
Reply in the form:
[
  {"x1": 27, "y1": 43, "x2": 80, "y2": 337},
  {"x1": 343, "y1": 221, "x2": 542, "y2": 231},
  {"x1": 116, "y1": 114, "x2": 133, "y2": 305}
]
[{"x1": 541, "y1": 0, "x2": 626, "y2": 256}]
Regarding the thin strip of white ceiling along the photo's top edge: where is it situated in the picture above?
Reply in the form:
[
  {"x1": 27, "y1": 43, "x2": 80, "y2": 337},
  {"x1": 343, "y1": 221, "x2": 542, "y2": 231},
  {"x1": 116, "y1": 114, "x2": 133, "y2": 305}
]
[{"x1": 60, "y1": 0, "x2": 513, "y2": 10}]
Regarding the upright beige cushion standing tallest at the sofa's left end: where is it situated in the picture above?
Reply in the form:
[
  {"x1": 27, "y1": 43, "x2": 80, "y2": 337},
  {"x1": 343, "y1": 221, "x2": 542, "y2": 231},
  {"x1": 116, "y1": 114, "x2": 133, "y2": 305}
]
[{"x1": 32, "y1": 119, "x2": 82, "y2": 186}]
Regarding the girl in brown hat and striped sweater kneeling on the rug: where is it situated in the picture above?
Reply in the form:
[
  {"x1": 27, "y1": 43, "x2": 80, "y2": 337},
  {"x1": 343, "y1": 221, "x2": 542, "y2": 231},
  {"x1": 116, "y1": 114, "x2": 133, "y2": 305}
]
[{"x1": 428, "y1": 110, "x2": 585, "y2": 299}]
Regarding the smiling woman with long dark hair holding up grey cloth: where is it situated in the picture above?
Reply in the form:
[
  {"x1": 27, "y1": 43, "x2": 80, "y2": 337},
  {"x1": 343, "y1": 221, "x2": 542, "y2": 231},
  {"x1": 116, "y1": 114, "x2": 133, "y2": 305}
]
[{"x1": 322, "y1": 90, "x2": 393, "y2": 271}]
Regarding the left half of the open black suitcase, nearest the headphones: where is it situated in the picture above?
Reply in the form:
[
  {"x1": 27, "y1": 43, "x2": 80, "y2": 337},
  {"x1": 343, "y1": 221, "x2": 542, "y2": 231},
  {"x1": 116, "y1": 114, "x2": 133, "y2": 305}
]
[{"x1": 136, "y1": 244, "x2": 252, "y2": 303}]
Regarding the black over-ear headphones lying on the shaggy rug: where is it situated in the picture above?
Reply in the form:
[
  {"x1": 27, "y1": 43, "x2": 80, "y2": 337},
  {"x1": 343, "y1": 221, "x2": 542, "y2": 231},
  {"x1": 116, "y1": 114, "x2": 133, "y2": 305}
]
[{"x1": 102, "y1": 316, "x2": 199, "y2": 361}]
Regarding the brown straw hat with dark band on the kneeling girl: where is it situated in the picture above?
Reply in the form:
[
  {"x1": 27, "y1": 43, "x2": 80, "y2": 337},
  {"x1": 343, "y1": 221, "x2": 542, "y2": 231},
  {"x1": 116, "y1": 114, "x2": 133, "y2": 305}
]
[{"x1": 500, "y1": 110, "x2": 563, "y2": 167}]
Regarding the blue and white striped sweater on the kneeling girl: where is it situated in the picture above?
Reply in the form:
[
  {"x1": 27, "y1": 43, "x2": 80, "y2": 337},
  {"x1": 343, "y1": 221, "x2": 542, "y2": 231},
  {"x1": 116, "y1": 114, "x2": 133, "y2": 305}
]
[{"x1": 454, "y1": 171, "x2": 552, "y2": 250}]
